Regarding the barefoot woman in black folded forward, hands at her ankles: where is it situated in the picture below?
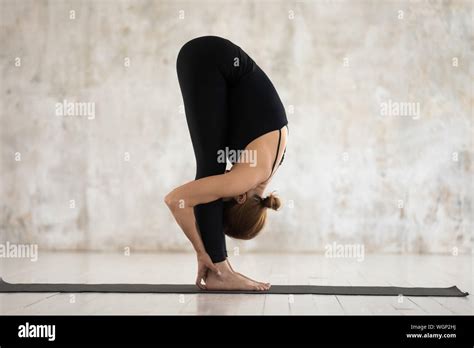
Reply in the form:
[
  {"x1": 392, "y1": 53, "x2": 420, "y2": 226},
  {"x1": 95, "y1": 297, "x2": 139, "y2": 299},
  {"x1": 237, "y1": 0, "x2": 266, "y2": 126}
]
[{"x1": 165, "y1": 36, "x2": 288, "y2": 290}]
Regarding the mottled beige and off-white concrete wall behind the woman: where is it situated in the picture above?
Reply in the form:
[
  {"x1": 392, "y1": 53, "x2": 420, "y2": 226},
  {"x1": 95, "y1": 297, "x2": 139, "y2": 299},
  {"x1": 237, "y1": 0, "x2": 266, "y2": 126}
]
[{"x1": 0, "y1": 0, "x2": 474, "y2": 252}]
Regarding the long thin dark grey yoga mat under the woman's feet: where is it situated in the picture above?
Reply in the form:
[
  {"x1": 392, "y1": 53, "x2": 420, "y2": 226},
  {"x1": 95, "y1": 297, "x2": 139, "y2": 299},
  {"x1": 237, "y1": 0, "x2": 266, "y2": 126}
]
[{"x1": 0, "y1": 278, "x2": 468, "y2": 297}]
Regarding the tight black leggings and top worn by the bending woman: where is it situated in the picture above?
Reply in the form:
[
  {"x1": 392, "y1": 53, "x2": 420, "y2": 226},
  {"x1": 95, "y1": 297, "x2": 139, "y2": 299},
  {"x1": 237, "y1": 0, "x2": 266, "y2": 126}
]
[{"x1": 176, "y1": 36, "x2": 286, "y2": 263}]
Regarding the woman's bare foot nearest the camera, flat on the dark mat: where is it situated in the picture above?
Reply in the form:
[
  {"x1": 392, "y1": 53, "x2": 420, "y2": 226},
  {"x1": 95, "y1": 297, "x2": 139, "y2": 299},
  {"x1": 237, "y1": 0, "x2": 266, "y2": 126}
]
[{"x1": 206, "y1": 261, "x2": 267, "y2": 291}]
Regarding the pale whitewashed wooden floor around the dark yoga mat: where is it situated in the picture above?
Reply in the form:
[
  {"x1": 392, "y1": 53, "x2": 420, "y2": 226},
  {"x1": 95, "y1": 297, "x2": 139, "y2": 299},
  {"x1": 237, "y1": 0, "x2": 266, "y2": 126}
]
[{"x1": 0, "y1": 253, "x2": 474, "y2": 315}]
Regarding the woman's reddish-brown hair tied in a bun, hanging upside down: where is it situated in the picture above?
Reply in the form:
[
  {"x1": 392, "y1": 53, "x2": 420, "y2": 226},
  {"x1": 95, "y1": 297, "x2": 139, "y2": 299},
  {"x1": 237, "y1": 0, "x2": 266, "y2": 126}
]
[{"x1": 224, "y1": 194, "x2": 281, "y2": 240}]
